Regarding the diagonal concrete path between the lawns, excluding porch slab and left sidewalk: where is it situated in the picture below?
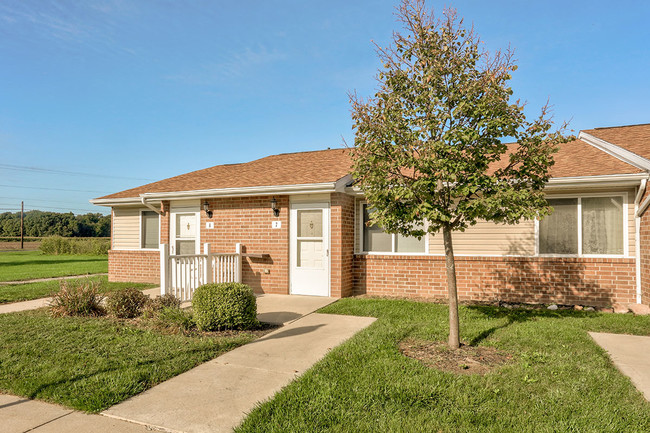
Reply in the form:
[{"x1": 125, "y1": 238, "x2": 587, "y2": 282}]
[{"x1": 102, "y1": 313, "x2": 375, "y2": 433}]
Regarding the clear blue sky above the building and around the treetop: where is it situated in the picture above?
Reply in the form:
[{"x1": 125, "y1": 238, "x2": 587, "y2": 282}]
[{"x1": 0, "y1": 0, "x2": 650, "y2": 213}]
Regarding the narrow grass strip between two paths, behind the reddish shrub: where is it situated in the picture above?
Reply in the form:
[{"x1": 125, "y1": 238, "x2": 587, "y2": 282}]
[{"x1": 0, "y1": 275, "x2": 156, "y2": 304}]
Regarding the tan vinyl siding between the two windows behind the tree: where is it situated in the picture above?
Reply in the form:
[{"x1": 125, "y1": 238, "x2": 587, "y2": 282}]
[{"x1": 429, "y1": 221, "x2": 535, "y2": 256}]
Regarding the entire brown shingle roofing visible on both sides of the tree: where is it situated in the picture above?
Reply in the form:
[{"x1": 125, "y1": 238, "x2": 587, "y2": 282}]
[{"x1": 100, "y1": 130, "x2": 650, "y2": 199}]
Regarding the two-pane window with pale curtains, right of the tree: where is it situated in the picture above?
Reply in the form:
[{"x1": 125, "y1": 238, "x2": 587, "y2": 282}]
[{"x1": 539, "y1": 196, "x2": 625, "y2": 255}]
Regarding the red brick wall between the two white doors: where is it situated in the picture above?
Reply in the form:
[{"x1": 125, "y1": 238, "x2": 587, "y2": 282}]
[{"x1": 201, "y1": 196, "x2": 289, "y2": 294}]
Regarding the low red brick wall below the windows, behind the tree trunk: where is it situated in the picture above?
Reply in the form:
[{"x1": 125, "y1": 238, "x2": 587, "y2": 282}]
[{"x1": 354, "y1": 255, "x2": 636, "y2": 306}]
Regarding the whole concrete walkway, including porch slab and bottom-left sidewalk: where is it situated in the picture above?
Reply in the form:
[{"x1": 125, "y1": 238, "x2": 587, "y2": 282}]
[{"x1": 0, "y1": 289, "x2": 375, "y2": 433}]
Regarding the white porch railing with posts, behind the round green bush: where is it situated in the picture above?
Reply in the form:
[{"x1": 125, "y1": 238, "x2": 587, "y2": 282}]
[{"x1": 160, "y1": 243, "x2": 242, "y2": 301}]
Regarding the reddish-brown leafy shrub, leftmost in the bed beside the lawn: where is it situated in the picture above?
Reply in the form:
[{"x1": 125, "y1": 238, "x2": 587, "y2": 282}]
[{"x1": 50, "y1": 280, "x2": 104, "y2": 317}]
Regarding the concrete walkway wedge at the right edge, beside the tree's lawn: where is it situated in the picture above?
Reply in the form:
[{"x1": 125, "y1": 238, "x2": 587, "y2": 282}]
[{"x1": 589, "y1": 332, "x2": 650, "y2": 401}]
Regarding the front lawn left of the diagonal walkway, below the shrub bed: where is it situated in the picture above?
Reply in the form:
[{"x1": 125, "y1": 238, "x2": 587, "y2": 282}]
[{"x1": 0, "y1": 310, "x2": 255, "y2": 412}]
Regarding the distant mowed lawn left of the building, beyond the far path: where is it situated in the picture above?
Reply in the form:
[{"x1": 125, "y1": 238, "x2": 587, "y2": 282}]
[{"x1": 0, "y1": 251, "x2": 108, "y2": 281}]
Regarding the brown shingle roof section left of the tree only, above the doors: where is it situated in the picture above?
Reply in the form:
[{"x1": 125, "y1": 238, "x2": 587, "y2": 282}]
[{"x1": 95, "y1": 149, "x2": 350, "y2": 199}]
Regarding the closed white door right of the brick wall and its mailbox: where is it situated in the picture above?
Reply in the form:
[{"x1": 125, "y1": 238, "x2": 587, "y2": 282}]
[{"x1": 289, "y1": 203, "x2": 330, "y2": 296}]
